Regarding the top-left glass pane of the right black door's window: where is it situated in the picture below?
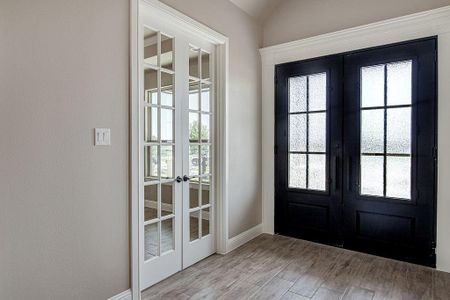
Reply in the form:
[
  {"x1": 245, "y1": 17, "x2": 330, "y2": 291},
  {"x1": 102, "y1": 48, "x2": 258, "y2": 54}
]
[{"x1": 361, "y1": 65, "x2": 384, "y2": 107}]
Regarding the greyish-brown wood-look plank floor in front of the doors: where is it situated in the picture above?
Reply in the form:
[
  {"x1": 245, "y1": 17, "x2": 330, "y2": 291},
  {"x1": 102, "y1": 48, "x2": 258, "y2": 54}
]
[{"x1": 142, "y1": 234, "x2": 450, "y2": 300}]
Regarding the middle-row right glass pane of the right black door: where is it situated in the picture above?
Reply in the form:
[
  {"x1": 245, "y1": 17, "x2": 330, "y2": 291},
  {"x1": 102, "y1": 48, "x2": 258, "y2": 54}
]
[{"x1": 387, "y1": 107, "x2": 411, "y2": 154}]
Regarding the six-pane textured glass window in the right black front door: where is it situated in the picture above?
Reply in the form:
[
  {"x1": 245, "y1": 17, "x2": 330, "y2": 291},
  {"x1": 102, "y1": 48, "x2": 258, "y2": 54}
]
[{"x1": 360, "y1": 61, "x2": 412, "y2": 200}]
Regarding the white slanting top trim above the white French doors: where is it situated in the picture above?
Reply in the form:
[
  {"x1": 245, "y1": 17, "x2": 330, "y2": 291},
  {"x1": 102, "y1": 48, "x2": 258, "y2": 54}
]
[{"x1": 142, "y1": 0, "x2": 228, "y2": 44}]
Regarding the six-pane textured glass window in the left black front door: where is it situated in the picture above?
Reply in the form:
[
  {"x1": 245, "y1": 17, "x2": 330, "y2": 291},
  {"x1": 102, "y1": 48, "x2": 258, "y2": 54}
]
[{"x1": 289, "y1": 73, "x2": 327, "y2": 191}]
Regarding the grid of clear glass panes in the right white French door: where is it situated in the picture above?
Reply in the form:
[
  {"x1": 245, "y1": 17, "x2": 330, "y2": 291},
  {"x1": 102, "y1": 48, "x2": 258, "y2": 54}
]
[{"x1": 189, "y1": 47, "x2": 213, "y2": 241}]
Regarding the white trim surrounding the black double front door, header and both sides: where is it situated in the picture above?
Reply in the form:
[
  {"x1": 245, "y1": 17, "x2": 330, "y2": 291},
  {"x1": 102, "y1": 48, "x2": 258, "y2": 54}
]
[{"x1": 260, "y1": 6, "x2": 450, "y2": 272}]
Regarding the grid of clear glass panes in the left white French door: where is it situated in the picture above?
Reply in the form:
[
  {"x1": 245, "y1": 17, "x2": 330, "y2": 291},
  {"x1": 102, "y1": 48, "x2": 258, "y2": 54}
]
[{"x1": 141, "y1": 27, "x2": 175, "y2": 260}]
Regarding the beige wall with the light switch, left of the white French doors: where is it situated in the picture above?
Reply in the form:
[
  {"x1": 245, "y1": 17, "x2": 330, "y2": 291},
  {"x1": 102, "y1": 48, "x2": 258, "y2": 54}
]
[{"x1": 0, "y1": 0, "x2": 130, "y2": 300}]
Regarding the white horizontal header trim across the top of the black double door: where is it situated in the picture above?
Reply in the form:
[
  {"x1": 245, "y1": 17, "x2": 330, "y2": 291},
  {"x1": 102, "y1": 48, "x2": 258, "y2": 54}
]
[{"x1": 259, "y1": 6, "x2": 450, "y2": 62}]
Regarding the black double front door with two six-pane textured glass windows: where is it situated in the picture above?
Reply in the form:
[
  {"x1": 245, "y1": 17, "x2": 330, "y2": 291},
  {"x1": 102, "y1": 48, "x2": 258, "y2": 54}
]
[{"x1": 275, "y1": 38, "x2": 437, "y2": 266}]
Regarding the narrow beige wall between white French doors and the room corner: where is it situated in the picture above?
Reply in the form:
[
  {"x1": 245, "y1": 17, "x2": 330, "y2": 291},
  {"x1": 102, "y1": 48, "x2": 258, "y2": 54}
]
[{"x1": 162, "y1": 0, "x2": 262, "y2": 238}]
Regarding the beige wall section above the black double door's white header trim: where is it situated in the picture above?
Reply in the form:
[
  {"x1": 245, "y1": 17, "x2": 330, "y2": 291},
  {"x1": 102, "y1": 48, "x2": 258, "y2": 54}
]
[{"x1": 263, "y1": 0, "x2": 450, "y2": 46}]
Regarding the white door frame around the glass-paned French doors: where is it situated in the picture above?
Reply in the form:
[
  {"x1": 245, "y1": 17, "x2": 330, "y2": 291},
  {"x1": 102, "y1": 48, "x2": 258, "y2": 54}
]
[{"x1": 130, "y1": 0, "x2": 229, "y2": 300}]
